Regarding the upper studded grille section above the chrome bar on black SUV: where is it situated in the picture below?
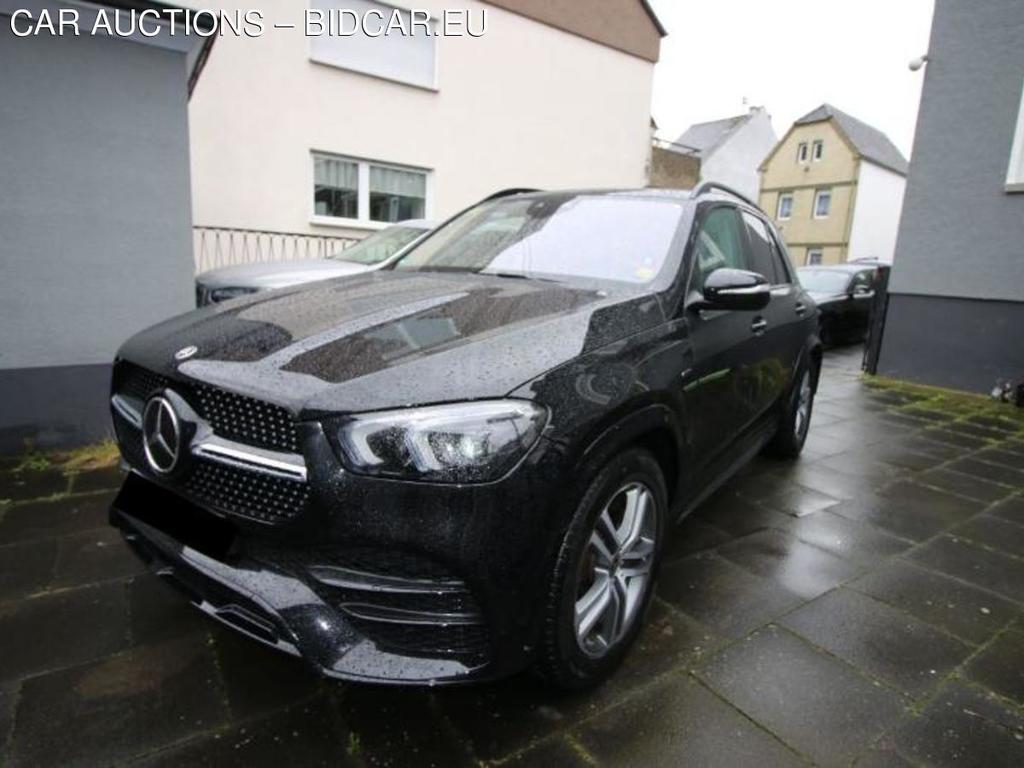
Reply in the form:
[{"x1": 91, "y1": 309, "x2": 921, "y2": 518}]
[{"x1": 115, "y1": 362, "x2": 299, "y2": 454}]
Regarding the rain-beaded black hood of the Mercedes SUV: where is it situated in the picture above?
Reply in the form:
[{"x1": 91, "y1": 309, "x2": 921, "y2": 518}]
[{"x1": 120, "y1": 271, "x2": 664, "y2": 416}]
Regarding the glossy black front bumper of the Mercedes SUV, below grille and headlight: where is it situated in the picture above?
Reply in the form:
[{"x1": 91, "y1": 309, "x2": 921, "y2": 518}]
[{"x1": 111, "y1": 434, "x2": 569, "y2": 685}]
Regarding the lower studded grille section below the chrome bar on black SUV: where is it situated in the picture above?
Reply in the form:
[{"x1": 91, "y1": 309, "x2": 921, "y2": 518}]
[{"x1": 184, "y1": 460, "x2": 309, "y2": 524}]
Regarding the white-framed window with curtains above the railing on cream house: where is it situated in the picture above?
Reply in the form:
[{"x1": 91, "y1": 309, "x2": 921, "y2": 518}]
[{"x1": 312, "y1": 153, "x2": 427, "y2": 223}]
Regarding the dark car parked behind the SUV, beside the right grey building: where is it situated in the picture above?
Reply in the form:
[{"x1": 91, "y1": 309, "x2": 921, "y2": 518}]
[{"x1": 798, "y1": 261, "x2": 889, "y2": 346}]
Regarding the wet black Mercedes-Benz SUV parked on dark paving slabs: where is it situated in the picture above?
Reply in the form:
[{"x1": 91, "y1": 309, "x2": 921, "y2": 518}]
[{"x1": 111, "y1": 184, "x2": 821, "y2": 688}]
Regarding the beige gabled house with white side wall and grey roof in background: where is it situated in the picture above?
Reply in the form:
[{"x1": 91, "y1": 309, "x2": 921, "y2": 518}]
[{"x1": 759, "y1": 104, "x2": 907, "y2": 265}]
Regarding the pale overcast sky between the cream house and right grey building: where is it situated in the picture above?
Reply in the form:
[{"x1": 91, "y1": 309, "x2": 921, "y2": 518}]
[{"x1": 649, "y1": 0, "x2": 934, "y2": 157}]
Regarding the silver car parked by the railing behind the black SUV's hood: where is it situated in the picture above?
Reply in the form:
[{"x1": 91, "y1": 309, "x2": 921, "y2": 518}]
[{"x1": 196, "y1": 219, "x2": 434, "y2": 306}]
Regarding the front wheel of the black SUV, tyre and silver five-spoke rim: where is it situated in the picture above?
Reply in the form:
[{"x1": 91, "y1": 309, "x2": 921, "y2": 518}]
[{"x1": 537, "y1": 449, "x2": 668, "y2": 690}]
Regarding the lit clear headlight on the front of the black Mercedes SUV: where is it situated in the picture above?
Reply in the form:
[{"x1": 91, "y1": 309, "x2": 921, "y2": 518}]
[{"x1": 335, "y1": 400, "x2": 547, "y2": 482}]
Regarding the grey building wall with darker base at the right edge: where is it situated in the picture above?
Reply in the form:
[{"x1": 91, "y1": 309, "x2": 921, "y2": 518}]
[{"x1": 879, "y1": 0, "x2": 1024, "y2": 391}]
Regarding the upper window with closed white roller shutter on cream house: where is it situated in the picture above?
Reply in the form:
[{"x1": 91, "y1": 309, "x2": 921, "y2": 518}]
[{"x1": 309, "y1": 0, "x2": 437, "y2": 88}]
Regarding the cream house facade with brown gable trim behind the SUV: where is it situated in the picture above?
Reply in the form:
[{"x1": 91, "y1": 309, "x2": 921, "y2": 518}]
[{"x1": 189, "y1": 0, "x2": 664, "y2": 264}]
